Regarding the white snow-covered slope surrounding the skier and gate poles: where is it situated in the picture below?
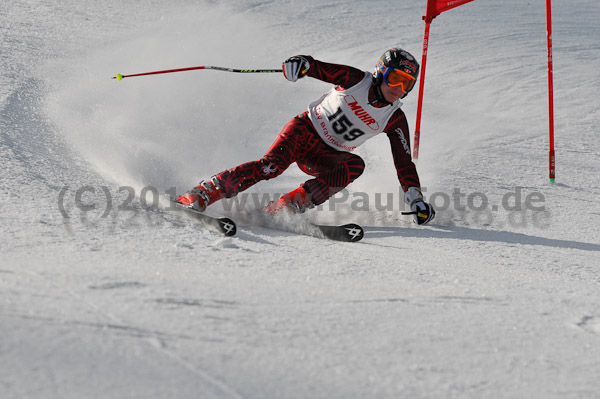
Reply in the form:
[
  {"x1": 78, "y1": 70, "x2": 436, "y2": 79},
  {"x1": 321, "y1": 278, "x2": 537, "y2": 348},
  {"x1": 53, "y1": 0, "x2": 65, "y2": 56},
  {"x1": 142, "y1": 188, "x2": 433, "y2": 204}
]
[{"x1": 0, "y1": 0, "x2": 600, "y2": 399}]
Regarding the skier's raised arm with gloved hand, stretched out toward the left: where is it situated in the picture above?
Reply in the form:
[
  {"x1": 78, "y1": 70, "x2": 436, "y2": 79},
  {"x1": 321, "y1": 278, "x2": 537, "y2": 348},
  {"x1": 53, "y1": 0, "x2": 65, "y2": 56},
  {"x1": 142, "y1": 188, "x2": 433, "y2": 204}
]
[{"x1": 283, "y1": 55, "x2": 365, "y2": 89}]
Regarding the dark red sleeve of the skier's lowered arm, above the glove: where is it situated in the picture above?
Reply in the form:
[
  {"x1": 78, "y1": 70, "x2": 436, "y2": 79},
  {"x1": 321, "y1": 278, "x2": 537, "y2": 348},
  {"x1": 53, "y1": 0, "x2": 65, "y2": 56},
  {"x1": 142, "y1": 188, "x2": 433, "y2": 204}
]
[{"x1": 385, "y1": 109, "x2": 421, "y2": 191}]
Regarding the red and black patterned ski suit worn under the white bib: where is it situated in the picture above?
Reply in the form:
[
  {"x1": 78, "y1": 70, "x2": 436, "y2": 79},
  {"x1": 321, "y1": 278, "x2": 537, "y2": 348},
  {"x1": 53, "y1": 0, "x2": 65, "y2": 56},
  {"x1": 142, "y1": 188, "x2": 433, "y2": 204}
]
[{"x1": 216, "y1": 56, "x2": 420, "y2": 205}]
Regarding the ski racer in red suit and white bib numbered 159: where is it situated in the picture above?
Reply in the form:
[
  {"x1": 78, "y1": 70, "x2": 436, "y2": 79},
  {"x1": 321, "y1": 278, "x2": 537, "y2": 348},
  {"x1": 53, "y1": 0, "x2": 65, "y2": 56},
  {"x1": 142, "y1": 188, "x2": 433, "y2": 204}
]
[{"x1": 176, "y1": 48, "x2": 435, "y2": 224}]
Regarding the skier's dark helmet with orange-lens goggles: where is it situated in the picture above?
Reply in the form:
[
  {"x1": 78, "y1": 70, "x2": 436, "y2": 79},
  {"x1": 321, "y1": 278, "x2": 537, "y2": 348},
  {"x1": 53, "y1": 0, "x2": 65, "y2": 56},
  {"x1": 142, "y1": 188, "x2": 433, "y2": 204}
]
[{"x1": 373, "y1": 48, "x2": 419, "y2": 98}]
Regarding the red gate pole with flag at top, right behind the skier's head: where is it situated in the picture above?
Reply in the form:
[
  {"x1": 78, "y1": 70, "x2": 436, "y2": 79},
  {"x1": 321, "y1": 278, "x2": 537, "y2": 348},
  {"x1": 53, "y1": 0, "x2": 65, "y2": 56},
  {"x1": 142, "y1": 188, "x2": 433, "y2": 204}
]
[{"x1": 413, "y1": 0, "x2": 473, "y2": 161}]
